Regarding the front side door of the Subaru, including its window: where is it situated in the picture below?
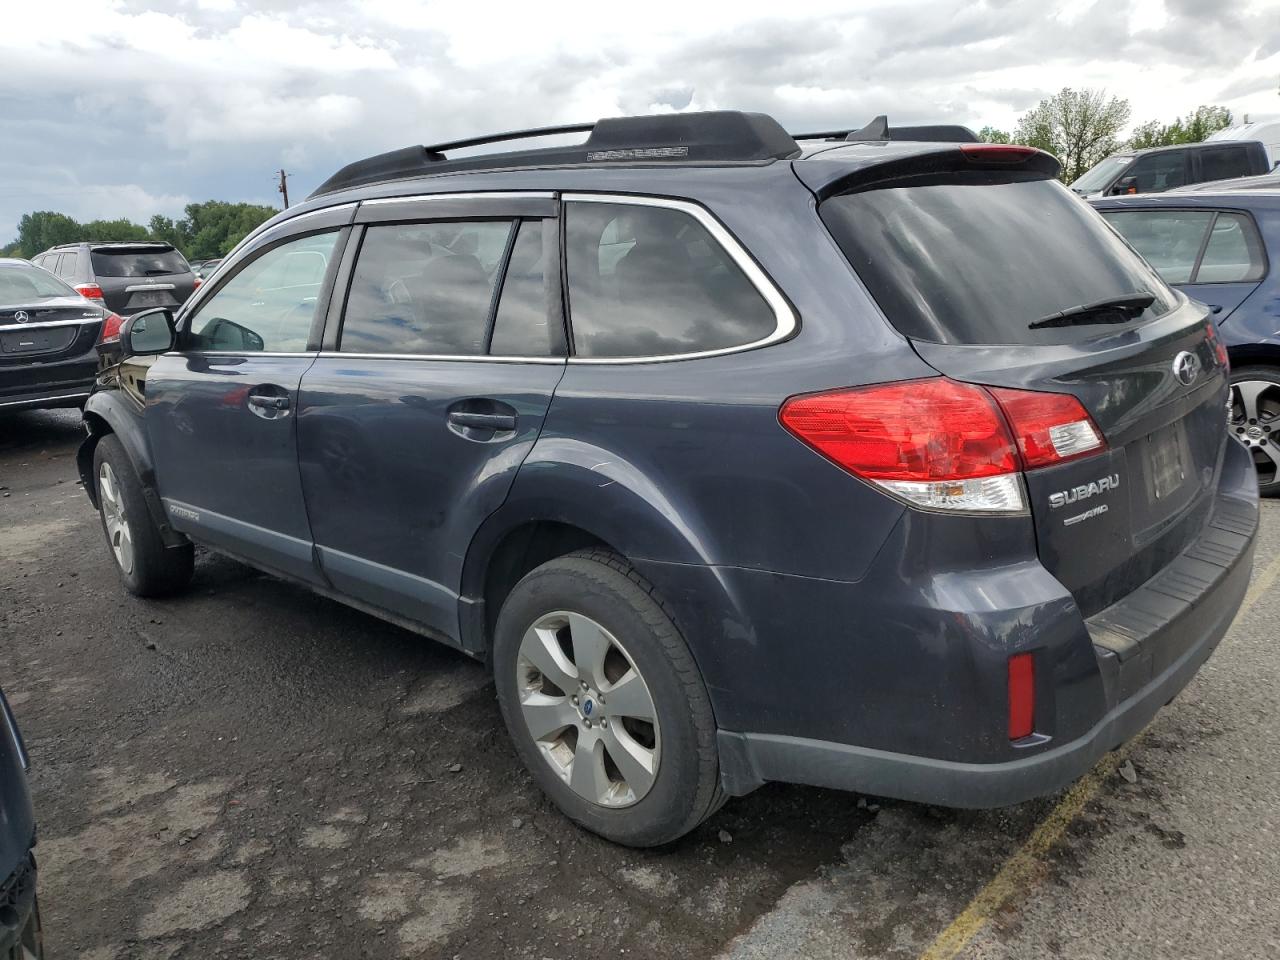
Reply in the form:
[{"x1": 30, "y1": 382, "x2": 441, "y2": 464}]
[{"x1": 143, "y1": 206, "x2": 353, "y2": 584}]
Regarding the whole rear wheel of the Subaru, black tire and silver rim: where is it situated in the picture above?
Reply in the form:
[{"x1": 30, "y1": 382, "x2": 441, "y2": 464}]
[{"x1": 493, "y1": 550, "x2": 726, "y2": 847}]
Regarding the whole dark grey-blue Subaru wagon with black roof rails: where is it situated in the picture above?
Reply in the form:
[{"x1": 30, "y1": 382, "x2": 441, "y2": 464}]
[{"x1": 79, "y1": 113, "x2": 1258, "y2": 845}]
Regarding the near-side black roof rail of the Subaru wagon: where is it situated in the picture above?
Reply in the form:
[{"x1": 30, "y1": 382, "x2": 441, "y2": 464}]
[{"x1": 311, "y1": 110, "x2": 800, "y2": 197}]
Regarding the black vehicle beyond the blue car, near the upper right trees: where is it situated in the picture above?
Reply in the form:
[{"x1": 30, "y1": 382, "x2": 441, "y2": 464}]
[{"x1": 1071, "y1": 140, "x2": 1271, "y2": 198}]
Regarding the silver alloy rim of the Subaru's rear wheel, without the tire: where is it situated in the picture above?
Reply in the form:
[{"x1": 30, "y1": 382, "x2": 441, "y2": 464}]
[{"x1": 516, "y1": 611, "x2": 660, "y2": 808}]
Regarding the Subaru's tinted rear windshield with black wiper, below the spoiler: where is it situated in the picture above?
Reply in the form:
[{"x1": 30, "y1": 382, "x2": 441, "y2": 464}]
[{"x1": 820, "y1": 174, "x2": 1178, "y2": 344}]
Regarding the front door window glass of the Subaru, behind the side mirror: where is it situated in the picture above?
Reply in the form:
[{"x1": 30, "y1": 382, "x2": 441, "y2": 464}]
[{"x1": 187, "y1": 230, "x2": 338, "y2": 353}]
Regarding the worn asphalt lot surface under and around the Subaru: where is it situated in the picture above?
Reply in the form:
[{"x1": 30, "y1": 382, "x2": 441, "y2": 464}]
[{"x1": 0, "y1": 411, "x2": 1280, "y2": 960}]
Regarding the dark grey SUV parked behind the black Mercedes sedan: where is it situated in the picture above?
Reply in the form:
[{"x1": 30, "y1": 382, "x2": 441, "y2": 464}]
[{"x1": 32, "y1": 241, "x2": 200, "y2": 316}]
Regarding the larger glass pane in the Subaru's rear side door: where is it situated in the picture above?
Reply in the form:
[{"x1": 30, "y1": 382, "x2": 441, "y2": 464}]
[{"x1": 339, "y1": 220, "x2": 519, "y2": 356}]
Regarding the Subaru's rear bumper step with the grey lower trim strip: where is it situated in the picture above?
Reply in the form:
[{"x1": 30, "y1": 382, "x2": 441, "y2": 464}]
[{"x1": 719, "y1": 444, "x2": 1258, "y2": 808}]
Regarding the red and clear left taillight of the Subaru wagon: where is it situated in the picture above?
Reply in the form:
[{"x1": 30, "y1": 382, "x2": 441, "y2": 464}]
[{"x1": 778, "y1": 376, "x2": 1106, "y2": 513}]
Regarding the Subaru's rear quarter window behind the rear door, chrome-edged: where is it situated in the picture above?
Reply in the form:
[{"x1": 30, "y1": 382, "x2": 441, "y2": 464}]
[{"x1": 566, "y1": 201, "x2": 777, "y2": 357}]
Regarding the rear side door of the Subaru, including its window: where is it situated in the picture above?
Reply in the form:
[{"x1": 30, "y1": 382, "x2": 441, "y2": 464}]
[{"x1": 298, "y1": 195, "x2": 566, "y2": 639}]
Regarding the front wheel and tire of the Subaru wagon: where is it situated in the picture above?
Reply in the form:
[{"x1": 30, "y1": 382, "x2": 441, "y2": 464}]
[{"x1": 93, "y1": 434, "x2": 195, "y2": 596}]
